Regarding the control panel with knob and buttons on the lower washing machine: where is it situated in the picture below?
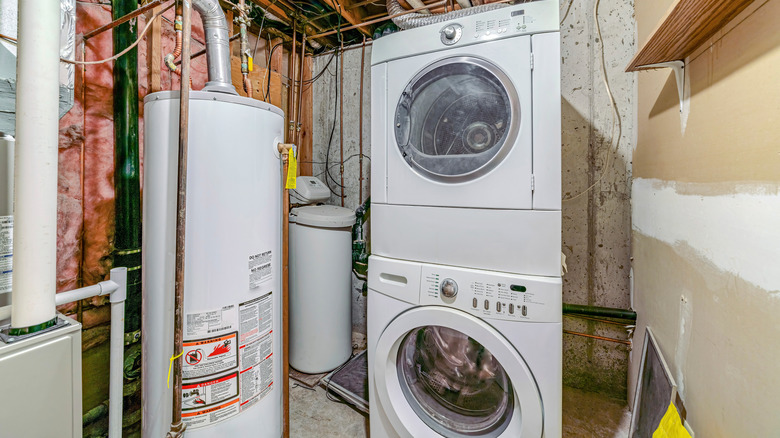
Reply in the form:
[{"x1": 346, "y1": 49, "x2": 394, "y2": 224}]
[{"x1": 420, "y1": 265, "x2": 562, "y2": 322}]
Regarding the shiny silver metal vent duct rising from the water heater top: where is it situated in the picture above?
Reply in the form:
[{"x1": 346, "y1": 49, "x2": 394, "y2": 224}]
[{"x1": 192, "y1": 0, "x2": 238, "y2": 94}]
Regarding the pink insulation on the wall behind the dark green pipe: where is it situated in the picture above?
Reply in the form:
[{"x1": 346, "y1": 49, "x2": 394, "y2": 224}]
[{"x1": 57, "y1": 2, "x2": 207, "y2": 300}]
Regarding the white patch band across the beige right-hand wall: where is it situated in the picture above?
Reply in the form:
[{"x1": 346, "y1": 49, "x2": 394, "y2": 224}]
[{"x1": 632, "y1": 178, "x2": 780, "y2": 297}]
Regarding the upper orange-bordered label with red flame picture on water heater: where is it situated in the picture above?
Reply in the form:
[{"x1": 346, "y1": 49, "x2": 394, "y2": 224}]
[{"x1": 182, "y1": 332, "x2": 238, "y2": 379}]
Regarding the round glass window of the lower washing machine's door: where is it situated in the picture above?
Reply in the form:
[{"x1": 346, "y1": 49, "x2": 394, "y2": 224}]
[{"x1": 396, "y1": 326, "x2": 515, "y2": 437}]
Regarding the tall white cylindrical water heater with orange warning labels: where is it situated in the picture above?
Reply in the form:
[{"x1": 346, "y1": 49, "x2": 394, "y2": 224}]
[{"x1": 142, "y1": 91, "x2": 284, "y2": 438}]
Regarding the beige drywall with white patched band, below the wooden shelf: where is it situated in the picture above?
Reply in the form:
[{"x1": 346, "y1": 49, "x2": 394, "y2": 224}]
[{"x1": 630, "y1": 0, "x2": 780, "y2": 437}]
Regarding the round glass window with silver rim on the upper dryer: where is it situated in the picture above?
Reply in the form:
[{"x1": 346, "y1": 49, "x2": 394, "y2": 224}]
[{"x1": 395, "y1": 56, "x2": 520, "y2": 182}]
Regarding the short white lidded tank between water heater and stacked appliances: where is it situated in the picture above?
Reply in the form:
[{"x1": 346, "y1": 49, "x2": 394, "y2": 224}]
[{"x1": 290, "y1": 205, "x2": 355, "y2": 374}]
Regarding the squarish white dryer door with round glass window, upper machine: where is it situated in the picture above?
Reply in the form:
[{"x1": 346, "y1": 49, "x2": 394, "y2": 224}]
[{"x1": 386, "y1": 37, "x2": 533, "y2": 209}]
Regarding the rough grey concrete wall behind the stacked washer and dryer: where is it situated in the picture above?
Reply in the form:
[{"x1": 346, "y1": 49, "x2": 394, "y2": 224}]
[{"x1": 314, "y1": 0, "x2": 635, "y2": 398}]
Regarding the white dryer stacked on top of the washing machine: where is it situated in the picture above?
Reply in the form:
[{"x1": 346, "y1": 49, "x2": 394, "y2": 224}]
[{"x1": 371, "y1": 0, "x2": 561, "y2": 276}]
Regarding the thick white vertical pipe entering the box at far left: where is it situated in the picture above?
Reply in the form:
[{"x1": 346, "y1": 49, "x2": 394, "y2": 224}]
[{"x1": 11, "y1": 0, "x2": 60, "y2": 328}]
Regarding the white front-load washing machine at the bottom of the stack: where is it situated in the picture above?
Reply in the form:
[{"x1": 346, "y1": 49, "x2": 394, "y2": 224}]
[{"x1": 368, "y1": 256, "x2": 562, "y2": 438}]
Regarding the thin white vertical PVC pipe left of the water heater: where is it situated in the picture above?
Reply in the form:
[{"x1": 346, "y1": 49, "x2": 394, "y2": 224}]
[{"x1": 107, "y1": 268, "x2": 127, "y2": 438}]
